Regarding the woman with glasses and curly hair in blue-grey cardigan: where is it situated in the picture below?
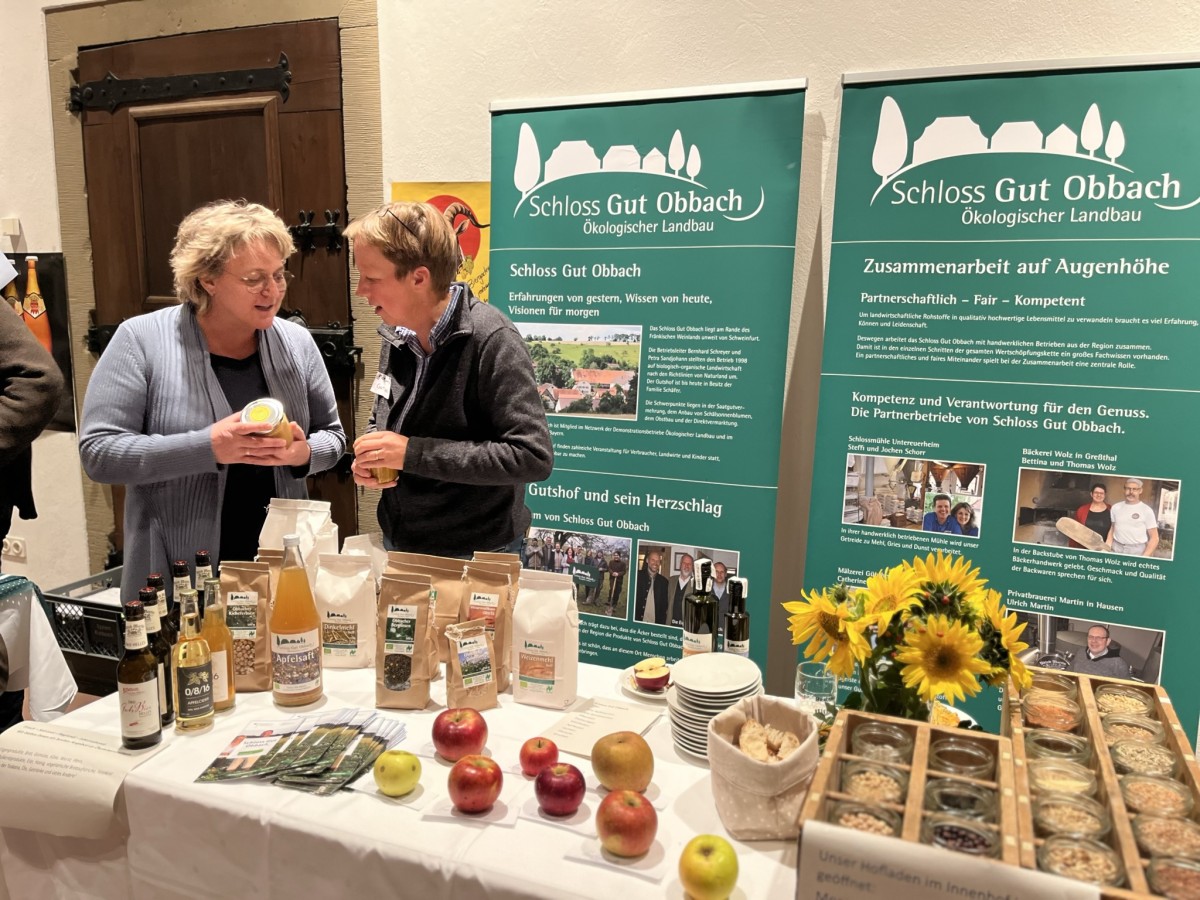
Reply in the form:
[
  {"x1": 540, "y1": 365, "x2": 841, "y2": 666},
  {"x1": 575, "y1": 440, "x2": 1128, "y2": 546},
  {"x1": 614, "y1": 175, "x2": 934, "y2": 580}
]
[{"x1": 79, "y1": 200, "x2": 346, "y2": 600}]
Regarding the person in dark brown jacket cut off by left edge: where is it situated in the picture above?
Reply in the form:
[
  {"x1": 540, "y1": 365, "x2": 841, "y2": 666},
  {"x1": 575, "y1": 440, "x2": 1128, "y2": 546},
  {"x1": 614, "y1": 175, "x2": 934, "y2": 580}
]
[{"x1": 0, "y1": 286, "x2": 62, "y2": 732}]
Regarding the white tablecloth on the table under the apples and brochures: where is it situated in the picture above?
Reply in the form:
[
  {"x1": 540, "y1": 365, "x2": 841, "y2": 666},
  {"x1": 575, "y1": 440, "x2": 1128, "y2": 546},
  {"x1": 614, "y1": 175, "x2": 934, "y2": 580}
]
[{"x1": 0, "y1": 665, "x2": 796, "y2": 900}]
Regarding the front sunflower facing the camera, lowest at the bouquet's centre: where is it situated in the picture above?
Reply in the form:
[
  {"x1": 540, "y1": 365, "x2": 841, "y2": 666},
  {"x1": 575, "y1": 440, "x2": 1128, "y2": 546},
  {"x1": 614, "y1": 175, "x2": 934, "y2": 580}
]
[{"x1": 896, "y1": 616, "x2": 991, "y2": 701}]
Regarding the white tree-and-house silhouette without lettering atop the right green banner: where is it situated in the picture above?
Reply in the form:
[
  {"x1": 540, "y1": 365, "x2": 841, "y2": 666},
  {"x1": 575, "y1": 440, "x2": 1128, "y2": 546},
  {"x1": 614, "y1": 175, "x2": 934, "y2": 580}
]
[{"x1": 871, "y1": 96, "x2": 1137, "y2": 209}]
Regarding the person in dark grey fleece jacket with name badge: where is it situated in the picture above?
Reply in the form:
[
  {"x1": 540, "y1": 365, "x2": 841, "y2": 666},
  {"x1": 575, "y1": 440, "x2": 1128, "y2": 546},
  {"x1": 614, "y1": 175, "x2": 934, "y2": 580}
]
[{"x1": 346, "y1": 203, "x2": 553, "y2": 557}]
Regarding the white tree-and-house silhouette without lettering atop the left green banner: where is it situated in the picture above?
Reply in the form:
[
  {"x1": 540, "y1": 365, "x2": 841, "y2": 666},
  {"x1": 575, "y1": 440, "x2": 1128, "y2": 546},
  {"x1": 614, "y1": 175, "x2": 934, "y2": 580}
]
[{"x1": 512, "y1": 122, "x2": 766, "y2": 222}]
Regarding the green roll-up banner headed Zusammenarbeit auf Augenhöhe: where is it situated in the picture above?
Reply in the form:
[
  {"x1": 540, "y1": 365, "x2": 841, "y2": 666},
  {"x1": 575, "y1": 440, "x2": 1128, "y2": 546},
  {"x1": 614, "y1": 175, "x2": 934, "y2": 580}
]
[{"x1": 805, "y1": 65, "x2": 1200, "y2": 731}]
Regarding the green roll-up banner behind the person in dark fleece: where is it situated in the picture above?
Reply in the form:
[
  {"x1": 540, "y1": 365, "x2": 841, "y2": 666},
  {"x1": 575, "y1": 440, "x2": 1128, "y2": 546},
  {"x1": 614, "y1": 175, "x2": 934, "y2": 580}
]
[{"x1": 492, "y1": 82, "x2": 804, "y2": 667}]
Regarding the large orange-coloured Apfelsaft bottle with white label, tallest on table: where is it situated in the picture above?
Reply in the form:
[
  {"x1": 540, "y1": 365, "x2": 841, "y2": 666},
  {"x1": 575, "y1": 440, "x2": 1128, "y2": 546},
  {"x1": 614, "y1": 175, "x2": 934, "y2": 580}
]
[{"x1": 270, "y1": 534, "x2": 325, "y2": 707}]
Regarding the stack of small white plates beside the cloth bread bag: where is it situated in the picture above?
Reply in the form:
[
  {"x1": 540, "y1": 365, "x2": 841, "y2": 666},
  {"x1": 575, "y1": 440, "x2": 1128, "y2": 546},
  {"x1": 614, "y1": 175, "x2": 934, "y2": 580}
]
[{"x1": 667, "y1": 653, "x2": 762, "y2": 760}]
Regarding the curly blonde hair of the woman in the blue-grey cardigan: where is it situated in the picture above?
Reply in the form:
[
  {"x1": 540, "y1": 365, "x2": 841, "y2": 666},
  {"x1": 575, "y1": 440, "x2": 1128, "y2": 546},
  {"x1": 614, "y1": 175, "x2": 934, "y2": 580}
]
[{"x1": 170, "y1": 200, "x2": 296, "y2": 316}]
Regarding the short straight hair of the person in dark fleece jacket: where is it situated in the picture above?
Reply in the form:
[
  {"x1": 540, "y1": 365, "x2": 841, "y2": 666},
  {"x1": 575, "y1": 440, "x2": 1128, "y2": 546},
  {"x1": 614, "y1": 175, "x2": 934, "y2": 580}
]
[{"x1": 344, "y1": 202, "x2": 462, "y2": 294}]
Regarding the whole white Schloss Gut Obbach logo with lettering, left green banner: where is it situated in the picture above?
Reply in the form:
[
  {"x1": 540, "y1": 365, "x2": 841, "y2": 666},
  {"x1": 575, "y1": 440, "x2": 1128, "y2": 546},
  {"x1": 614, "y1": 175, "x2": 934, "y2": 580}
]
[{"x1": 512, "y1": 122, "x2": 767, "y2": 236}]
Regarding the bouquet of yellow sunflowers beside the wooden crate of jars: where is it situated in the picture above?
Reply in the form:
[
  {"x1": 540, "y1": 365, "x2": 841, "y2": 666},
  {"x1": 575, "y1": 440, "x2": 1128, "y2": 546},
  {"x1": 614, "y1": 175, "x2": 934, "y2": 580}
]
[{"x1": 782, "y1": 551, "x2": 1030, "y2": 720}]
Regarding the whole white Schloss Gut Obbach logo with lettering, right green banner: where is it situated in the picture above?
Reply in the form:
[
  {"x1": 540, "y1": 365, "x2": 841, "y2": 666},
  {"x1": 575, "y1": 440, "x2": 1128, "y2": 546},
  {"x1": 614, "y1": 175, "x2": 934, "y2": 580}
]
[{"x1": 871, "y1": 97, "x2": 1200, "y2": 227}]
